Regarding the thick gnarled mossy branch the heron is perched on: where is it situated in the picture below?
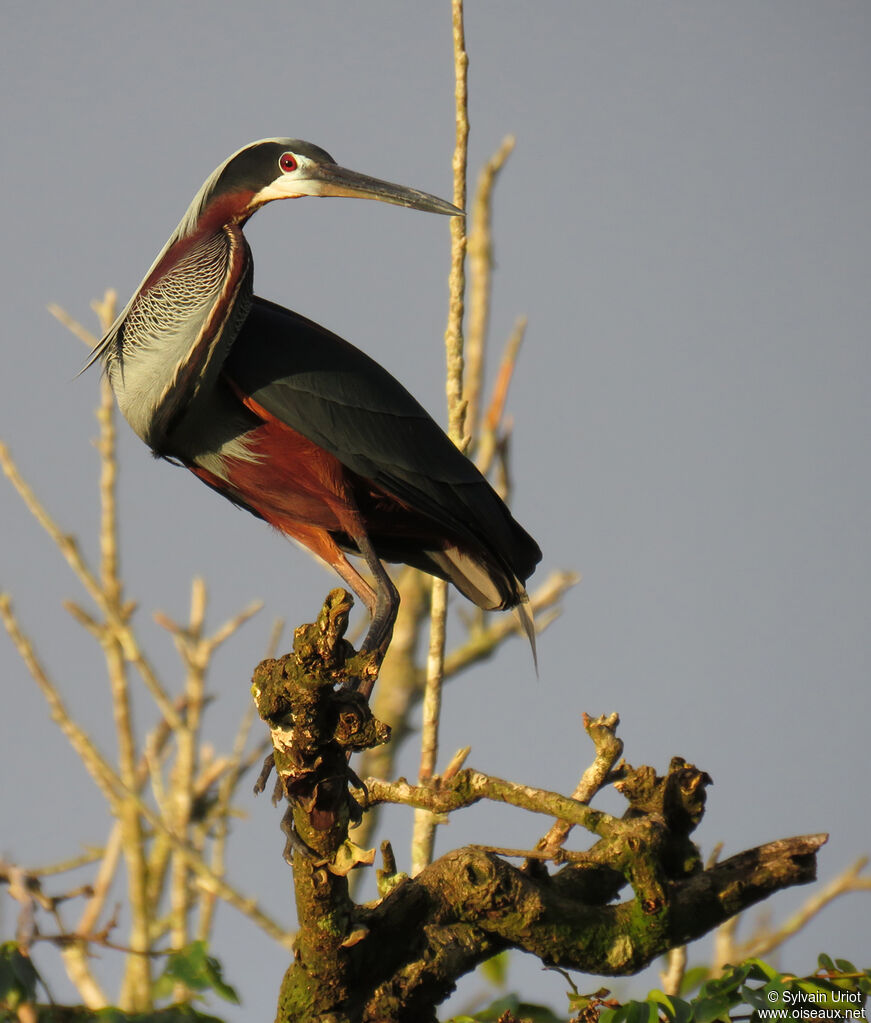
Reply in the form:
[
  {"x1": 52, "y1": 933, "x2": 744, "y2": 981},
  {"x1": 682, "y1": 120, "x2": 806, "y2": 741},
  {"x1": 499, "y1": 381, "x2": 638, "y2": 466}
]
[{"x1": 254, "y1": 589, "x2": 825, "y2": 1023}]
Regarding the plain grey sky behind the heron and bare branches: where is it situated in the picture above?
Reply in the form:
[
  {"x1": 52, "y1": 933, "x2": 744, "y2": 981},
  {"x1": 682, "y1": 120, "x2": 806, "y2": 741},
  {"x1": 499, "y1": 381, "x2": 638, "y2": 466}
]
[{"x1": 0, "y1": 0, "x2": 871, "y2": 1020}]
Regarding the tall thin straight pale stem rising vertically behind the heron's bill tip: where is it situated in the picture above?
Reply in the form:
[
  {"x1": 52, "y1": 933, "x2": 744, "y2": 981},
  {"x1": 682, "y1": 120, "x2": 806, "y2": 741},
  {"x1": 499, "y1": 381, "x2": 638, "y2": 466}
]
[{"x1": 411, "y1": 0, "x2": 469, "y2": 874}]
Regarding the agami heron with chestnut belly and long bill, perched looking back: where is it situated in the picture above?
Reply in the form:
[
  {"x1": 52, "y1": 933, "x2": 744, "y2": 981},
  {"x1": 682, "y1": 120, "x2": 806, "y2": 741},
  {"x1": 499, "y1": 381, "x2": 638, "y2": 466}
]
[{"x1": 93, "y1": 138, "x2": 540, "y2": 652}]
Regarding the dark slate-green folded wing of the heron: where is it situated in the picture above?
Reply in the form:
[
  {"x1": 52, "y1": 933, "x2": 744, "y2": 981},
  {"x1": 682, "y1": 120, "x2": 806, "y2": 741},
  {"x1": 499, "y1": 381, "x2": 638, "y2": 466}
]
[{"x1": 224, "y1": 298, "x2": 540, "y2": 581}]
